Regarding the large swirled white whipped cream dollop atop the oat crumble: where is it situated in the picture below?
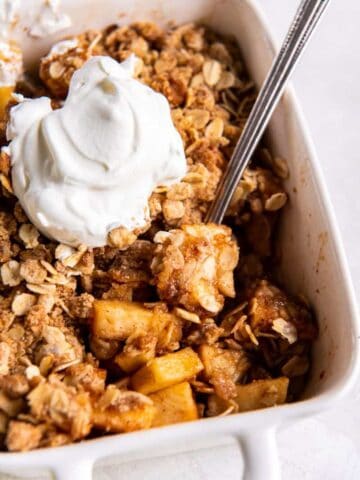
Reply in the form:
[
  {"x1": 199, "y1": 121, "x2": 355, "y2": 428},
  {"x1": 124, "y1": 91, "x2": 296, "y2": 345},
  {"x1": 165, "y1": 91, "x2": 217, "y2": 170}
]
[{"x1": 7, "y1": 55, "x2": 186, "y2": 247}]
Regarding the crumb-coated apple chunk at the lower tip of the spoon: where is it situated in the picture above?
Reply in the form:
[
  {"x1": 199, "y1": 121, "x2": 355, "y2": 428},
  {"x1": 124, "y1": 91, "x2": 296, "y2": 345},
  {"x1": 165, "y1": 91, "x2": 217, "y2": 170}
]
[{"x1": 152, "y1": 224, "x2": 239, "y2": 315}]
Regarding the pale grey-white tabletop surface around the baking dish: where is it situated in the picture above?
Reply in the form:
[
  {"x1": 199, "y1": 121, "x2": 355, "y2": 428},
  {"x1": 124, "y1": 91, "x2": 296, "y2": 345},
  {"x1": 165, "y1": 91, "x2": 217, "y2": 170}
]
[{"x1": 95, "y1": 0, "x2": 360, "y2": 480}]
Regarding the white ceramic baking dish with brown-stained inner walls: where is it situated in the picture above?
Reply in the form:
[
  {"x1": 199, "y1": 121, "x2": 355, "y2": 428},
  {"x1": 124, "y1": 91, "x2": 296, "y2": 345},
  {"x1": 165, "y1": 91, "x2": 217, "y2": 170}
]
[{"x1": 0, "y1": 0, "x2": 360, "y2": 480}]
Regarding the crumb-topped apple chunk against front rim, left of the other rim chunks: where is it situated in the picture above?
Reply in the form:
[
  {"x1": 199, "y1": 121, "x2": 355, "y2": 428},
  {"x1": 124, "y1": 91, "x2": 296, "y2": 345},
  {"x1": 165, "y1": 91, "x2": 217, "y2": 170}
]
[{"x1": 93, "y1": 385, "x2": 155, "y2": 432}]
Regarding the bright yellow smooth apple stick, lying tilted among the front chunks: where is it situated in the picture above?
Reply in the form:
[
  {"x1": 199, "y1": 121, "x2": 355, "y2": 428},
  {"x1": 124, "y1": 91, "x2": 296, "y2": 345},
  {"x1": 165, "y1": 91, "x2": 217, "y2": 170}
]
[{"x1": 131, "y1": 347, "x2": 203, "y2": 394}]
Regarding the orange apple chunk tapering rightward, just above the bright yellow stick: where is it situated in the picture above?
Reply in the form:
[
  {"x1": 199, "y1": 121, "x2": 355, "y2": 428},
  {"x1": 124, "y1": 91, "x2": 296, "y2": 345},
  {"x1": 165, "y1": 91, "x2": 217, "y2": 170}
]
[{"x1": 92, "y1": 300, "x2": 173, "y2": 340}]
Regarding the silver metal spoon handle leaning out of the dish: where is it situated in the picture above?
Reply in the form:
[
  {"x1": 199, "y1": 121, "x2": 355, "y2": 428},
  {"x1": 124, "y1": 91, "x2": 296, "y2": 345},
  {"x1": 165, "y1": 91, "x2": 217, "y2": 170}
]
[{"x1": 206, "y1": 0, "x2": 330, "y2": 223}]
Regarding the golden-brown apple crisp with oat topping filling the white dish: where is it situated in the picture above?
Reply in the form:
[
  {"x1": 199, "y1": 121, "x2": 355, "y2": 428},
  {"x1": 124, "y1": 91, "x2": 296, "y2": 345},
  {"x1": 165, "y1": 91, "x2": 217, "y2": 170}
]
[{"x1": 0, "y1": 22, "x2": 317, "y2": 451}]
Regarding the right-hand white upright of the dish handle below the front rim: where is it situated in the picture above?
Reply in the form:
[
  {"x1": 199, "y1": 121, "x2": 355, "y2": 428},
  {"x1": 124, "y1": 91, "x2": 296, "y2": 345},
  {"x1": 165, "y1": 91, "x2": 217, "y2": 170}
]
[{"x1": 237, "y1": 428, "x2": 281, "y2": 480}]
